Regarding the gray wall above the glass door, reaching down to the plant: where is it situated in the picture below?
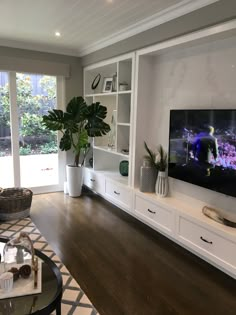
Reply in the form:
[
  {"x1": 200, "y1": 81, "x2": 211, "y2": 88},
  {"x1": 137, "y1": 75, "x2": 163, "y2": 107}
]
[{"x1": 0, "y1": 46, "x2": 83, "y2": 102}]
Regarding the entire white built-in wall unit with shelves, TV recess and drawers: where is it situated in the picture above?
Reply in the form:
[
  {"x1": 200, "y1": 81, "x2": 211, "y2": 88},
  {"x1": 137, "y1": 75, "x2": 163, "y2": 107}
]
[{"x1": 84, "y1": 19, "x2": 236, "y2": 278}]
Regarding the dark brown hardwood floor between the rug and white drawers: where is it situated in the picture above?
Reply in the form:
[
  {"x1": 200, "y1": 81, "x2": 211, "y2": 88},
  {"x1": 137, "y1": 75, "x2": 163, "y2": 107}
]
[{"x1": 31, "y1": 192, "x2": 236, "y2": 315}]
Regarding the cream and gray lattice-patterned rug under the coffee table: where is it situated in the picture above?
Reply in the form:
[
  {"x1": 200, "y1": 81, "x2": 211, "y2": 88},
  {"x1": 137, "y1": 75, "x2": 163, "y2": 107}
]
[{"x1": 0, "y1": 218, "x2": 99, "y2": 315}]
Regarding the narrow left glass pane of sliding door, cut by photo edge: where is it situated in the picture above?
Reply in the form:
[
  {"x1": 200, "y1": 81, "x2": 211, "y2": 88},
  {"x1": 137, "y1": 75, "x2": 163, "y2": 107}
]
[{"x1": 0, "y1": 72, "x2": 14, "y2": 188}]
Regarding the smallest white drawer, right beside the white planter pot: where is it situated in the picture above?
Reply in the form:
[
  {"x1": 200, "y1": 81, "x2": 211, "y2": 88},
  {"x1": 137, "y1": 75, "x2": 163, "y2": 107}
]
[{"x1": 84, "y1": 169, "x2": 105, "y2": 194}]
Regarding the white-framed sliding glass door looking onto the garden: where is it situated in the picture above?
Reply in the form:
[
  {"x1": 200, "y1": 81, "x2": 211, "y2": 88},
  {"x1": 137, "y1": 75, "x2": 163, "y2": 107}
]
[{"x1": 0, "y1": 72, "x2": 64, "y2": 192}]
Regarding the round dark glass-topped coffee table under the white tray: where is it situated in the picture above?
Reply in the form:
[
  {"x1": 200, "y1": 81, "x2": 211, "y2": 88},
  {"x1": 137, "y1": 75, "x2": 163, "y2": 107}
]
[{"x1": 0, "y1": 238, "x2": 62, "y2": 315}]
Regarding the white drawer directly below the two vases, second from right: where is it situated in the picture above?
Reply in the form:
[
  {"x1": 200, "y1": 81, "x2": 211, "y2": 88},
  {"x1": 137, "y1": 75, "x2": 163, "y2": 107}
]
[{"x1": 134, "y1": 195, "x2": 173, "y2": 233}]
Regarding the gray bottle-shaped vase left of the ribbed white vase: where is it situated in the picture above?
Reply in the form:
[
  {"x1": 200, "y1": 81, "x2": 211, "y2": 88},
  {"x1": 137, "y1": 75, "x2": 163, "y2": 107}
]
[{"x1": 140, "y1": 157, "x2": 157, "y2": 192}]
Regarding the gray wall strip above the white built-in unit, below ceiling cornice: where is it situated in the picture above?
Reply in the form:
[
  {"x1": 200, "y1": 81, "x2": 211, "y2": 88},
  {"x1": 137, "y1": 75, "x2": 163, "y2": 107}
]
[{"x1": 82, "y1": 0, "x2": 236, "y2": 66}]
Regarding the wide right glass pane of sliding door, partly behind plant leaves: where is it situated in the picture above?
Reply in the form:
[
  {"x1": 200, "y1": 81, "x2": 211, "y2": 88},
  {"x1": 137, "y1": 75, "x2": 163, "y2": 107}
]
[{"x1": 16, "y1": 73, "x2": 58, "y2": 187}]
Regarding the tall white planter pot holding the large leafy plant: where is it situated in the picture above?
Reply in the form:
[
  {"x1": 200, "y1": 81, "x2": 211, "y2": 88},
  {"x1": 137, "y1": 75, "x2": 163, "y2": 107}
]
[{"x1": 66, "y1": 165, "x2": 83, "y2": 197}]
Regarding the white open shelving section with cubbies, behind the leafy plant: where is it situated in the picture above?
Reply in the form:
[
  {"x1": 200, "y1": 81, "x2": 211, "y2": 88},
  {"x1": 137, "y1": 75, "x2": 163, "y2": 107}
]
[{"x1": 84, "y1": 53, "x2": 134, "y2": 186}]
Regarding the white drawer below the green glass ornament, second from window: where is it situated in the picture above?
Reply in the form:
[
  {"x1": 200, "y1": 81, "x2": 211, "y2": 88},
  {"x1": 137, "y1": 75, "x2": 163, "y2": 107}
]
[{"x1": 105, "y1": 180, "x2": 132, "y2": 209}]
